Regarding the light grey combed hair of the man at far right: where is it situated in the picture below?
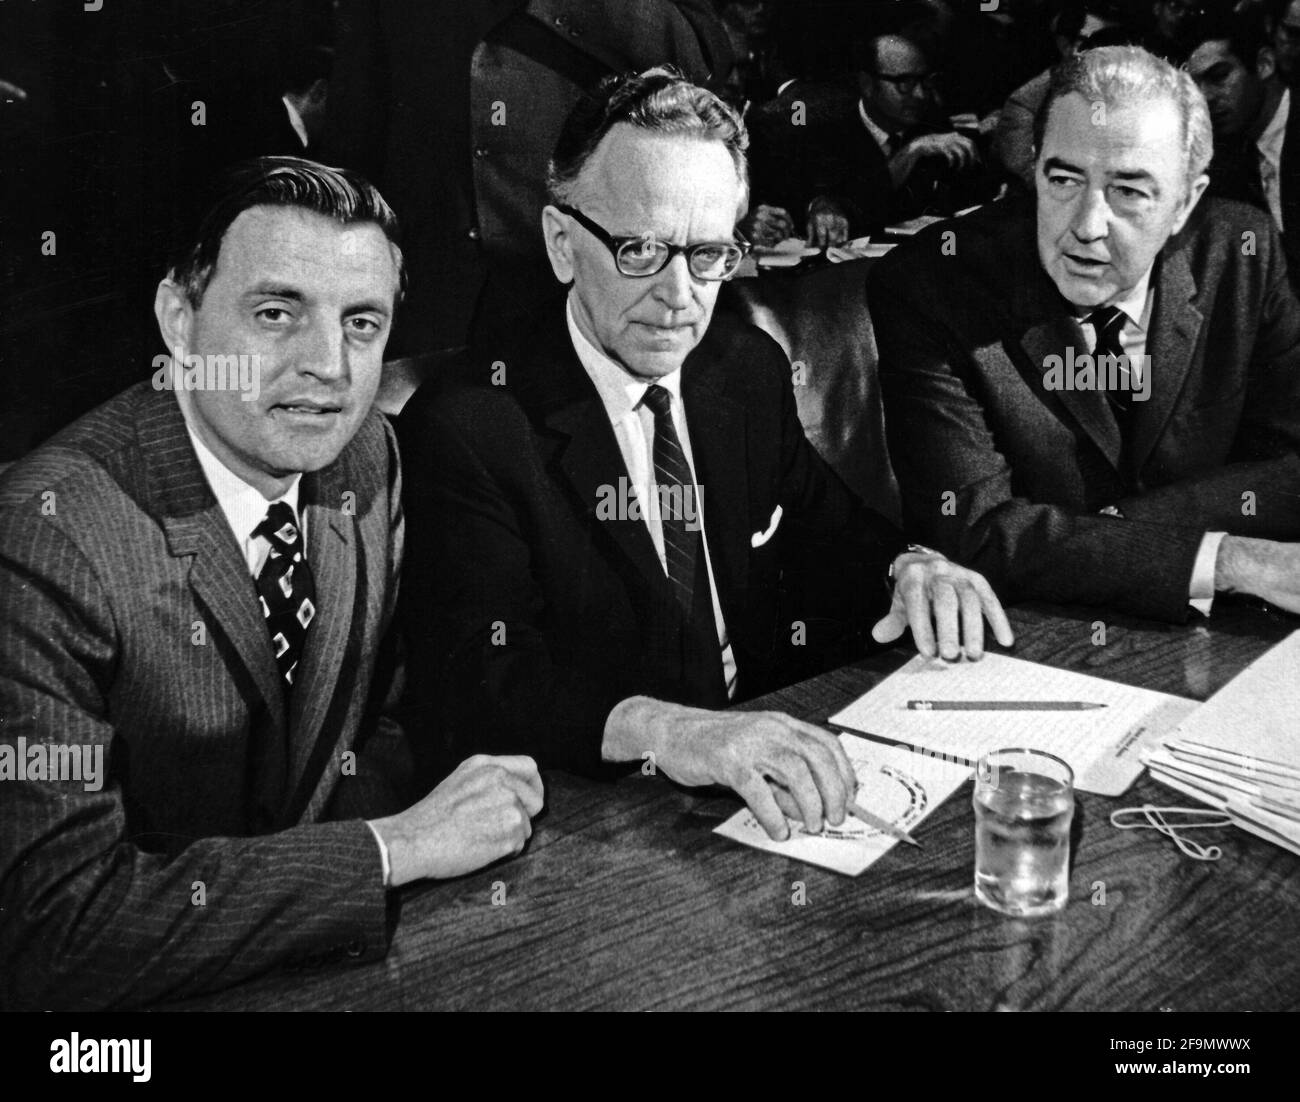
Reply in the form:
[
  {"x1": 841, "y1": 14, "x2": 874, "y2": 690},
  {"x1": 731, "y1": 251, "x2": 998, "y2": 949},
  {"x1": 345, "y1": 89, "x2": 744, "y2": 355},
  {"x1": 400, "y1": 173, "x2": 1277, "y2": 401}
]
[{"x1": 1034, "y1": 45, "x2": 1214, "y2": 186}]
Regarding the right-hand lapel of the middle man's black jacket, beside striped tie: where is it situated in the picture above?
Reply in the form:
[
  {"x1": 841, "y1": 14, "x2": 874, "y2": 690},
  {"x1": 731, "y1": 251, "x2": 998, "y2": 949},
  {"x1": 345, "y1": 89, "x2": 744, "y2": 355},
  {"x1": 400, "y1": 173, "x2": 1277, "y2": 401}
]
[{"x1": 681, "y1": 338, "x2": 750, "y2": 610}]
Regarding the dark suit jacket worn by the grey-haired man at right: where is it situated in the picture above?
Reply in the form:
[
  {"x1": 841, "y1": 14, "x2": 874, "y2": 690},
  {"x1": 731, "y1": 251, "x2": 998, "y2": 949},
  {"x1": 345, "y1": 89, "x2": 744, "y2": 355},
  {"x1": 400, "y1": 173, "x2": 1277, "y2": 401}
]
[{"x1": 868, "y1": 199, "x2": 1300, "y2": 620}]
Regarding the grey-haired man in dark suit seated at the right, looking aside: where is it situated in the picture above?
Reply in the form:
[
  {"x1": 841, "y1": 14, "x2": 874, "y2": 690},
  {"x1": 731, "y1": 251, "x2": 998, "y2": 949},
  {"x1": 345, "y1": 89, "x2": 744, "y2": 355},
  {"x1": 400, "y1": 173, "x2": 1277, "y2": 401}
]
[{"x1": 868, "y1": 47, "x2": 1300, "y2": 620}]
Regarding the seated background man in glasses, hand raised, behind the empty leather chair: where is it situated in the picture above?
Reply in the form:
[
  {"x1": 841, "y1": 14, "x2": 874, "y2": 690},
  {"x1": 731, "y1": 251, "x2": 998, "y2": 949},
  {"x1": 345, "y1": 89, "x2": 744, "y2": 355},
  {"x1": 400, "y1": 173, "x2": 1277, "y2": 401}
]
[{"x1": 755, "y1": 34, "x2": 995, "y2": 247}]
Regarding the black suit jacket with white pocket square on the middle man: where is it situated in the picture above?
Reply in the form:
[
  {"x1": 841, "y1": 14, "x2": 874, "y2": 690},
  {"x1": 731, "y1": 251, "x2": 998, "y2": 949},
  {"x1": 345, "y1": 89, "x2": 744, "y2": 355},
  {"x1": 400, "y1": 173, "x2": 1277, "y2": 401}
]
[{"x1": 398, "y1": 311, "x2": 902, "y2": 771}]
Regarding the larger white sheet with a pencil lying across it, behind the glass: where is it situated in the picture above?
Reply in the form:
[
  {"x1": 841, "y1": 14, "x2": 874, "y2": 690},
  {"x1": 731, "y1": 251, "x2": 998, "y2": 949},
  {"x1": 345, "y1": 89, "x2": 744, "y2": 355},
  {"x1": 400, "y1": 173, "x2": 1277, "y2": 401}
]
[{"x1": 831, "y1": 654, "x2": 1197, "y2": 795}]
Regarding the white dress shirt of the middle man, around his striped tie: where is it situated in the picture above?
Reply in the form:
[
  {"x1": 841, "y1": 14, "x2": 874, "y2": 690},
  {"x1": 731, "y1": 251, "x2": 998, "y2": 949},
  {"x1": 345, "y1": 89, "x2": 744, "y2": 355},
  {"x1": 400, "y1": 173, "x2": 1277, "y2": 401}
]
[{"x1": 566, "y1": 294, "x2": 736, "y2": 698}]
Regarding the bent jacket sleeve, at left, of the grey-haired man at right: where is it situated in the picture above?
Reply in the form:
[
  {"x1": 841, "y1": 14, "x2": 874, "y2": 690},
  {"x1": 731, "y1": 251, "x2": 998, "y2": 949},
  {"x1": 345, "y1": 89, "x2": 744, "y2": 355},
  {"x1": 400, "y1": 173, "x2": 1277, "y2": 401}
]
[{"x1": 870, "y1": 265, "x2": 1204, "y2": 621}]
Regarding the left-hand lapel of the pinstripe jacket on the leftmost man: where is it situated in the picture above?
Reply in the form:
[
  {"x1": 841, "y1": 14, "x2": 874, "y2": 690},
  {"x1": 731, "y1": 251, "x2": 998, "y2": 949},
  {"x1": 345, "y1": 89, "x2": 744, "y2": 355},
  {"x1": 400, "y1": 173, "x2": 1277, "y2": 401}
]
[{"x1": 137, "y1": 391, "x2": 285, "y2": 734}]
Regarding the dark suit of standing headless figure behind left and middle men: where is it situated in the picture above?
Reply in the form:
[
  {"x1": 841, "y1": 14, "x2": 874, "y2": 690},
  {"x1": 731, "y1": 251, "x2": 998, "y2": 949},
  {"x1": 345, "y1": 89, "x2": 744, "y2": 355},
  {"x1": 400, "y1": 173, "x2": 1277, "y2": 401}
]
[{"x1": 325, "y1": 0, "x2": 731, "y2": 355}]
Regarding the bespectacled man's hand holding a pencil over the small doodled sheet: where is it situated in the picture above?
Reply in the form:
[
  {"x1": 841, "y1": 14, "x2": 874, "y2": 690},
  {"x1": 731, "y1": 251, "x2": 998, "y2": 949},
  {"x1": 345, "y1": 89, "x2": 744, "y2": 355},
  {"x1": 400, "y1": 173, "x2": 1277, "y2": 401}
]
[{"x1": 603, "y1": 697, "x2": 857, "y2": 841}]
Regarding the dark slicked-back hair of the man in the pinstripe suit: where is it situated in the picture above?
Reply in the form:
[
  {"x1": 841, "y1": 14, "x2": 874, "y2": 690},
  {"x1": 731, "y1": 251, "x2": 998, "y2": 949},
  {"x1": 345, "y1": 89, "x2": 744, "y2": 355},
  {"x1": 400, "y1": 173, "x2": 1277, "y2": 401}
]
[{"x1": 168, "y1": 157, "x2": 406, "y2": 307}]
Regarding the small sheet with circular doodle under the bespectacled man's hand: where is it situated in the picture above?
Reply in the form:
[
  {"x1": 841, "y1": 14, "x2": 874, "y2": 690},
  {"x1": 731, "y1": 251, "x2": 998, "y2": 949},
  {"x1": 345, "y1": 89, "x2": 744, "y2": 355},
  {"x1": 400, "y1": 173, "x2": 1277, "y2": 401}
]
[{"x1": 714, "y1": 734, "x2": 971, "y2": 876}]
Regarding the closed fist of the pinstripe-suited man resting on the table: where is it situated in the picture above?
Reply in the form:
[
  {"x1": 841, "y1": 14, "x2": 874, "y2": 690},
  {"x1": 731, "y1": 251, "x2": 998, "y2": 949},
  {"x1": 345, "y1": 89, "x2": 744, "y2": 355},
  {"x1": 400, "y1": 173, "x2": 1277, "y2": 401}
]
[{"x1": 371, "y1": 754, "x2": 543, "y2": 888}]
